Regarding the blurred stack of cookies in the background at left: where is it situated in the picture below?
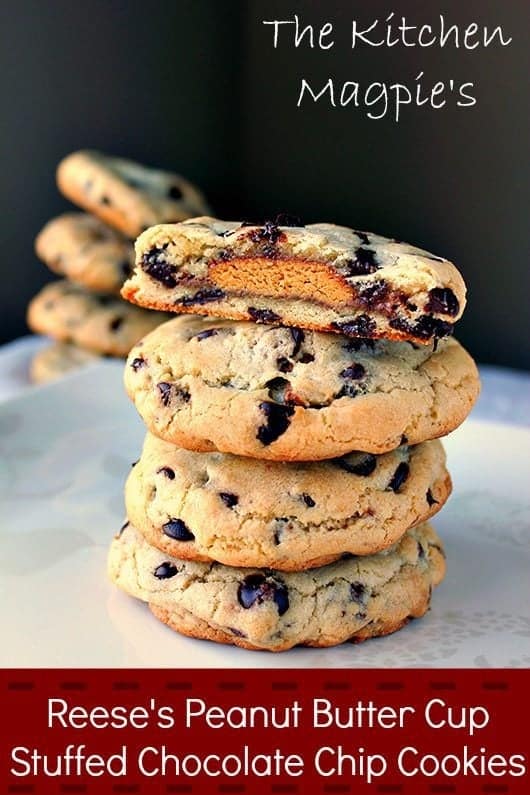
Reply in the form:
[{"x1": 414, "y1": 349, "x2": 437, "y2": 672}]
[{"x1": 28, "y1": 151, "x2": 207, "y2": 383}]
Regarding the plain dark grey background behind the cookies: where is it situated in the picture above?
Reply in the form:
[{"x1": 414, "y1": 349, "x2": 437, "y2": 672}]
[{"x1": 0, "y1": 0, "x2": 530, "y2": 367}]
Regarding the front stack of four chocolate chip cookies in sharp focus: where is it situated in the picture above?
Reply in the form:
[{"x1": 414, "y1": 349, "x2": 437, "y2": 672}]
[{"x1": 109, "y1": 217, "x2": 479, "y2": 651}]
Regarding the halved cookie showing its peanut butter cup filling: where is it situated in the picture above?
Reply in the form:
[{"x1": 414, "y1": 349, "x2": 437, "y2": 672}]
[{"x1": 122, "y1": 217, "x2": 466, "y2": 343}]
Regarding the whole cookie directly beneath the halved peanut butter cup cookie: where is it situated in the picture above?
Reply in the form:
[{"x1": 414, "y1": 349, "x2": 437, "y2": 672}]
[{"x1": 125, "y1": 316, "x2": 479, "y2": 461}]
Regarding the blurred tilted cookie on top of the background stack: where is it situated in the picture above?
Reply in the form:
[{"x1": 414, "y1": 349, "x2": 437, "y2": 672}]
[{"x1": 57, "y1": 149, "x2": 208, "y2": 239}]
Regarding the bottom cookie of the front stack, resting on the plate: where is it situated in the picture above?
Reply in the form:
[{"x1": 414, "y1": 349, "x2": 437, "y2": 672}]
[{"x1": 109, "y1": 524, "x2": 445, "y2": 651}]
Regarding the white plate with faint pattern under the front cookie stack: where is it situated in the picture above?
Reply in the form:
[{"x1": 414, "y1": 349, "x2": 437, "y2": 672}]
[{"x1": 0, "y1": 362, "x2": 530, "y2": 668}]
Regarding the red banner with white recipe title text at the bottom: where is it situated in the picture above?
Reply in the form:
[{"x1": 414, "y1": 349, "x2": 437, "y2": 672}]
[{"x1": 0, "y1": 670, "x2": 530, "y2": 795}]
